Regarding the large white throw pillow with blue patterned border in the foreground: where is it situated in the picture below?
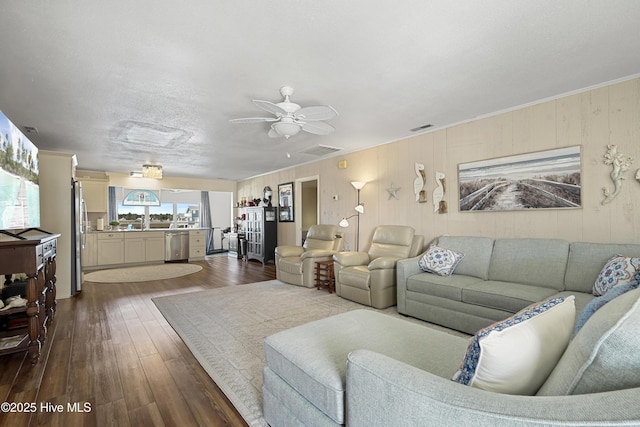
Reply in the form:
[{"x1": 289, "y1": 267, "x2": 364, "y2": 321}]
[{"x1": 452, "y1": 295, "x2": 575, "y2": 395}]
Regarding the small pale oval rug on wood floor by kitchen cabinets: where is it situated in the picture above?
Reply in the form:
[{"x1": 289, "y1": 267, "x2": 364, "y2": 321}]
[{"x1": 83, "y1": 263, "x2": 202, "y2": 283}]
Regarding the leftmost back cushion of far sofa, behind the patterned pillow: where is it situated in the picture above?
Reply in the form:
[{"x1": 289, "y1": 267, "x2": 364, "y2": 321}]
[{"x1": 438, "y1": 236, "x2": 493, "y2": 280}]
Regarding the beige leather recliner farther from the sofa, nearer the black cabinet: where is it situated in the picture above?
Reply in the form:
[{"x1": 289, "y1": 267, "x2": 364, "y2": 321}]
[{"x1": 276, "y1": 224, "x2": 343, "y2": 288}]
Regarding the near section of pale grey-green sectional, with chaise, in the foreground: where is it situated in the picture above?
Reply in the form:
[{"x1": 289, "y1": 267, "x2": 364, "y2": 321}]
[{"x1": 263, "y1": 288, "x2": 640, "y2": 427}]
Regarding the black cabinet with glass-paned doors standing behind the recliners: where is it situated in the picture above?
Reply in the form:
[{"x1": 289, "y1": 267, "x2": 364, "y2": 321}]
[{"x1": 245, "y1": 207, "x2": 278, "y2": 264}]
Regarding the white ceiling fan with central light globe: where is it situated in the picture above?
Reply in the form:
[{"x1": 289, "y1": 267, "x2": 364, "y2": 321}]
[{"x1": 229, "y1": 86, "x2": 338, "y2": 139}]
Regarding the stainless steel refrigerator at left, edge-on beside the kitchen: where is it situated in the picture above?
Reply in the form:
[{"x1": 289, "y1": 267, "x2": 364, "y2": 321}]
[{"x1": 71, "y1": 178, "x2": 88, "y2": 295}]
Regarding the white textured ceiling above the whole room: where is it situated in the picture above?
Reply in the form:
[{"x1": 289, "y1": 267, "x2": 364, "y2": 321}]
[{"x1": 0, "y1": 0, "x2": 640, "y2": 180}]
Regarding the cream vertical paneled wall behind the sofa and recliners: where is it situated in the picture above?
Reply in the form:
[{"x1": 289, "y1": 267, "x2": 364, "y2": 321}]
[{"x1": 238, "y1": 78, "x2": 640, "y2": 250}]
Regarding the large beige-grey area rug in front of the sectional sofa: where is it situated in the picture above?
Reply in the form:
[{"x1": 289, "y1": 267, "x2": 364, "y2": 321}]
[{"x1": 153, "y1": 280, "x2": 463, "y2": 426}]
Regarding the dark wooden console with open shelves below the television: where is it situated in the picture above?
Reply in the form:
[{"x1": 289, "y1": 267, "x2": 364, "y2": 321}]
[{"x1": 0, "y1": 230, "x2": 60, "y2": 363}]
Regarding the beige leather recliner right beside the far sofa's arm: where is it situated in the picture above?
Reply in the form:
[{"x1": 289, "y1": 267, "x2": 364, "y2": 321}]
[{"x1": 333, "y1": 225, "x2": 424, "y2": 308}]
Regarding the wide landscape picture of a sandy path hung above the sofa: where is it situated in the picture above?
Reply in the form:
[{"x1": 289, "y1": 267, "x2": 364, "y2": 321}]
[{"x1": 458, "y1": 146, "x2": 582, "y2": 212}]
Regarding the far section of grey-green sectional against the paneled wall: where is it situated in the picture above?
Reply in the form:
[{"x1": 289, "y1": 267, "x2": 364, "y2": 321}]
[{"x1": 397, "y1": 236, "x2": 640, "y2": 334}]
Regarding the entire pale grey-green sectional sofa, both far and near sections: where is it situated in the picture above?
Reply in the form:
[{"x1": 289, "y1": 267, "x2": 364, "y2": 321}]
[{"x1": 263, "y1": 237, "x2": 640, "y2": 427}]
